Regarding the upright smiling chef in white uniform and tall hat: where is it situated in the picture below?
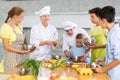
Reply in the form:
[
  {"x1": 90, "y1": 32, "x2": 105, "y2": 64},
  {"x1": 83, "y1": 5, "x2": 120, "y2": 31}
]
[{"x1": 30, "y1": 6, "x2": 58, "y2": 60}]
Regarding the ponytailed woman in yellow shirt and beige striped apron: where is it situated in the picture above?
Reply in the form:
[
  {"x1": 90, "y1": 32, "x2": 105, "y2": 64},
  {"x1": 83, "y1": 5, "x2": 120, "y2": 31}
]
[{"x1": 0, "y1": 6, "x2": 30, "y2": 71}]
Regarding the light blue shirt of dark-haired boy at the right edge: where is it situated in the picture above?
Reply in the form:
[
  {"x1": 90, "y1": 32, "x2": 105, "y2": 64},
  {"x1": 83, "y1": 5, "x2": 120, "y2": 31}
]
[{"x1": 106, "y1": 23, "x2": 120, "y2": 80}]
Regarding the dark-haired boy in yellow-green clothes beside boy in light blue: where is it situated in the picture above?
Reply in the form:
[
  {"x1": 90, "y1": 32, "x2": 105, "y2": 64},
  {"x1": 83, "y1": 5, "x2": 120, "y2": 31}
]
[{"x1": 88, "y1": 7, "x2": 107, "y2": 62}]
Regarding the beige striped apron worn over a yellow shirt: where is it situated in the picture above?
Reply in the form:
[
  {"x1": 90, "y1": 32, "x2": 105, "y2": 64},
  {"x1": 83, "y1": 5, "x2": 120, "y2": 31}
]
[{"x1": 4, "y1": 27, "x2": 24, "y2": 71}]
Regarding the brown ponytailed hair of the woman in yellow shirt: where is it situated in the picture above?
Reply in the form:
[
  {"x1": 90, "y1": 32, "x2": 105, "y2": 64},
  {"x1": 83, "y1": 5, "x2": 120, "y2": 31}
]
[{"x1": 5, "y1": 6, "x2": 24, "y2": 23}]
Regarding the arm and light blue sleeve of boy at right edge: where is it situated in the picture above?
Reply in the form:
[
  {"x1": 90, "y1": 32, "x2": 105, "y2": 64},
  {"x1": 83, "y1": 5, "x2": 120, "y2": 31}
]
[{"x1": 96, "y1": 32, "x2": 120, "y2": 73}]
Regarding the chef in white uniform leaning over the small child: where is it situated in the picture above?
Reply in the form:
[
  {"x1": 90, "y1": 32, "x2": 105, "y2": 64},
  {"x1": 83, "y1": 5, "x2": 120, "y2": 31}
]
[{"x1": 63, "y1": 21, "x2": 91, "y2": 57}]
